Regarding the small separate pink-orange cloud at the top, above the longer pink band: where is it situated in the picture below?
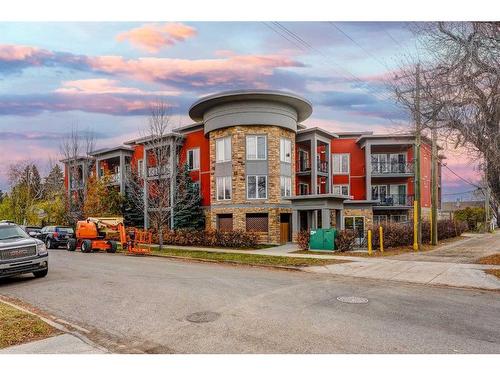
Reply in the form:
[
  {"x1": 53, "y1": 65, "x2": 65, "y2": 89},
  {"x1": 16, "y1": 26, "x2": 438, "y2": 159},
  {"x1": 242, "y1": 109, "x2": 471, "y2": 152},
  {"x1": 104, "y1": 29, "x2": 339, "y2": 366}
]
[{"x1": 116, "y1": 23, "x2": 196, "y2": 53}]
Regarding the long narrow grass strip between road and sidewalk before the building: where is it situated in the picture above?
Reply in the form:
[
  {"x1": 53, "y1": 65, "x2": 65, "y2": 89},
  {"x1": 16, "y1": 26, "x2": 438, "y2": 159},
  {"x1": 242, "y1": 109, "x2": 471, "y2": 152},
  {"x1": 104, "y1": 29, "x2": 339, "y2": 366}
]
[{"x1": 152, "y1": 249, "x2": 346, "y2": 267}]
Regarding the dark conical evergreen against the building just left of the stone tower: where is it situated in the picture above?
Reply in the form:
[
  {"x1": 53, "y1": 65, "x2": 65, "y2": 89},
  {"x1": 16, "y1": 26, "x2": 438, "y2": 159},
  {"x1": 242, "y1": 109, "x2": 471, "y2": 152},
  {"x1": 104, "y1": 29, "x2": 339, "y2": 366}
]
[{"x1": 174, "y1": 164, "x2": 205, "y2": 229}]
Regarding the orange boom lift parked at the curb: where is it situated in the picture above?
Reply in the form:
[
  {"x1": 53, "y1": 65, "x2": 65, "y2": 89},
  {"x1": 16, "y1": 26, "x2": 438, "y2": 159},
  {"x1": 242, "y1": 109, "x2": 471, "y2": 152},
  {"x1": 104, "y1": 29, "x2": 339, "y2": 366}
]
[{"x1": 67, "y1": 217, "x2": 127, "y2": 253}]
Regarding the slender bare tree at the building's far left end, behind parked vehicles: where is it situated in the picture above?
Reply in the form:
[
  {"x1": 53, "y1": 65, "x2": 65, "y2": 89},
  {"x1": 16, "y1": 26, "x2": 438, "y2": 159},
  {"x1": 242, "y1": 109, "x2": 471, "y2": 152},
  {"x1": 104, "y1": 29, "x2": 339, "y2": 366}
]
[{"x1": 59, "y1": 126, "x2": 95, "y2": 222}]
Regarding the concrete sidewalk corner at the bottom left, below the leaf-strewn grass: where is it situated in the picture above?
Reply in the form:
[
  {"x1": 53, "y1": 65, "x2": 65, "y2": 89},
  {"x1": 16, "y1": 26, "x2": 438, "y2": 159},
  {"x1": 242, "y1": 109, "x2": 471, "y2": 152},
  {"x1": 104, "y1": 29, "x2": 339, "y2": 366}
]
[{"x1": 0, "y1": 333, "x2": 106, "y2": 354}]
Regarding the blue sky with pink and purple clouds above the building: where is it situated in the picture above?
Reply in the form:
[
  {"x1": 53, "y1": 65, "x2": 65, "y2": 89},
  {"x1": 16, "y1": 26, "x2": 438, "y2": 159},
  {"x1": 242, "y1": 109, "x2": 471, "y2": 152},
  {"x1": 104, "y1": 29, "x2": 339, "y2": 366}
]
[{"x1": 0, "y1": 22, "x2": 479, "y2": 200}]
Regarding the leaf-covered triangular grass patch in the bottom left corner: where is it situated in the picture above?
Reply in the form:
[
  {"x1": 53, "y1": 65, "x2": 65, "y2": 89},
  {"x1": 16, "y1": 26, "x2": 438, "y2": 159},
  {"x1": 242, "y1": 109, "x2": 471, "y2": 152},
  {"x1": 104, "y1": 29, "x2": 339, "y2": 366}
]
[{"x1": 0, "y1": 302, "x2": 58, "y2": 349}]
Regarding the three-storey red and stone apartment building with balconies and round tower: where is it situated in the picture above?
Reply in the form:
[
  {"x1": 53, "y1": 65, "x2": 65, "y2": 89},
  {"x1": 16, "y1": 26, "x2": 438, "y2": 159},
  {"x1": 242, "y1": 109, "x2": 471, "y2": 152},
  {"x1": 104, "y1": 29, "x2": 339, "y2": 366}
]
[{"x1": 65, "y1": 90, "x2": 441, "y2": 244}]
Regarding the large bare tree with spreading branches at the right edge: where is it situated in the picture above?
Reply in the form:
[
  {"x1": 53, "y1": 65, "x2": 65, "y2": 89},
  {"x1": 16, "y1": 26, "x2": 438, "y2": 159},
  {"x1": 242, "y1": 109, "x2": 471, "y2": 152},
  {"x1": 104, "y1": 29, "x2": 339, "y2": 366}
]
[{"x1": 394, "y1": 22, "x2": 500, "y2": 212}]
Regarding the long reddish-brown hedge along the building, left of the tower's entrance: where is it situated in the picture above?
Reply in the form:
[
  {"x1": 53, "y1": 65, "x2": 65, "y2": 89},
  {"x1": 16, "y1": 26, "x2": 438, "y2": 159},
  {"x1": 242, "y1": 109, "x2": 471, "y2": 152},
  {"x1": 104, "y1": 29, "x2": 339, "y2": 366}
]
[{"x1": 153, "y1": 229, "x2": 257, "y2": 248}]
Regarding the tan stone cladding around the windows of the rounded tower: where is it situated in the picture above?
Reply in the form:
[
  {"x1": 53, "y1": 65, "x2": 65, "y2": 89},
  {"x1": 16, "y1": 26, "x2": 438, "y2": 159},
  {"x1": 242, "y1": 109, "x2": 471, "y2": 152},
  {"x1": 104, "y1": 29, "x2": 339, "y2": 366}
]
[{"x1": 206, "y1": 125, "x2": 295, "y2": 244}]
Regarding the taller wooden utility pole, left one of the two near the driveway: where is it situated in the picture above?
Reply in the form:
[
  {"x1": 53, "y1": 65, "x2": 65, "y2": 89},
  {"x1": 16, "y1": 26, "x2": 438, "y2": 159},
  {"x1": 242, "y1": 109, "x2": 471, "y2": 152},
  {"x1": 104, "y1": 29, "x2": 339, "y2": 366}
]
[{"x1": 413, "y1": 63, "x2": 422, "y2": 250}]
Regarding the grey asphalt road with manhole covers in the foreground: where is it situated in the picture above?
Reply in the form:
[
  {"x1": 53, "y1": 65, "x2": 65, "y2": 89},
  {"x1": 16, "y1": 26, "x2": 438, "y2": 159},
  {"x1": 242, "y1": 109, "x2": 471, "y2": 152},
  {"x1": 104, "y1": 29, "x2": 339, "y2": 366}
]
[{"x1": 0, "y1": 250, "x2": 500, "y2": 353}]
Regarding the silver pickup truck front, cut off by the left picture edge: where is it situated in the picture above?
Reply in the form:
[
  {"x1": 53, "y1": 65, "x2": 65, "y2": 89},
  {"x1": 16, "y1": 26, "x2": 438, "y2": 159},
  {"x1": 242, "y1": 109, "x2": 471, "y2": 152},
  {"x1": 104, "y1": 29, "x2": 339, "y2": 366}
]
[{"x1": 0, "y1": 222, "x2": 49, "y2": 278}]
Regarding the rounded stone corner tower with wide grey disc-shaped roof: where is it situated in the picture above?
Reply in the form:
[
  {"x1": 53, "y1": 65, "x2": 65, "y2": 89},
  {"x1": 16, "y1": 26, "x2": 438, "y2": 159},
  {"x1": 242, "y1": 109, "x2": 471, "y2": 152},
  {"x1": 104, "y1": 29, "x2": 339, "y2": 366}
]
[{"x1": 189, "y1": 90, "x2": 312, "y2": 243}]
